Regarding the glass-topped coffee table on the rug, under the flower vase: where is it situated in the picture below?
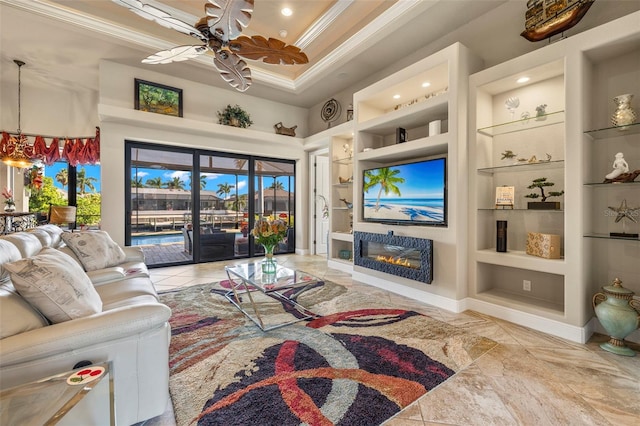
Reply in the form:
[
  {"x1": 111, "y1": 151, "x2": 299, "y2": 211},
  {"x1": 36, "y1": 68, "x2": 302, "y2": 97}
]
[{"x1": 225, "y1": 262, "x2": 322, "y2": 331}]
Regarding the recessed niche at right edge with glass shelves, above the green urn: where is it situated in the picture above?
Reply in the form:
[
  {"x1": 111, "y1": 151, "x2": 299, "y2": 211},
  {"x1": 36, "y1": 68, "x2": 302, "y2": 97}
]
[{"x1": 579, "y1": 28, "x2": 640, "y2": 341}]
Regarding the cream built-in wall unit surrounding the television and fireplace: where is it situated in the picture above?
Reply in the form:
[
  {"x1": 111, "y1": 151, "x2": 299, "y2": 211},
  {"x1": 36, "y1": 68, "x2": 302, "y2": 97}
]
[{"x1": 354, "y1": 43, "x2": 482, "y2": 304}]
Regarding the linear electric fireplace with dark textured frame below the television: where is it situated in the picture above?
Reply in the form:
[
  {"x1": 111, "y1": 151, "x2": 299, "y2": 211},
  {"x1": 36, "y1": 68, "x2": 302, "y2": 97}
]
[{"x1": 353, "y1": 231, "x2": 433, "y2": 284}]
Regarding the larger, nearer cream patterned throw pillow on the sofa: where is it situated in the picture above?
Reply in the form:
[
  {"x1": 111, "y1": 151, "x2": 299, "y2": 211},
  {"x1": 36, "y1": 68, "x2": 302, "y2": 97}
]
[{"x1": 4, "y1": 248, "x2": 102, "y2": 323}]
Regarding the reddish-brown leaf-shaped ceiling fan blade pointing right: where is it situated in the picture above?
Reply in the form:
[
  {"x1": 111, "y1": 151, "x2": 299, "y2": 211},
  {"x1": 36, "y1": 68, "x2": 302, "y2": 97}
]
[{"x1": 229, "y1": 36, "x2": 309, "y2": 65}]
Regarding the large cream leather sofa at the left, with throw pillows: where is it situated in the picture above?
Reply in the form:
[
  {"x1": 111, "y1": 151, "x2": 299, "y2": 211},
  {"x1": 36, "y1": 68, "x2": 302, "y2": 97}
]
[{"x1": 0, "y1": 225, "x2": 171, "y2": 425}]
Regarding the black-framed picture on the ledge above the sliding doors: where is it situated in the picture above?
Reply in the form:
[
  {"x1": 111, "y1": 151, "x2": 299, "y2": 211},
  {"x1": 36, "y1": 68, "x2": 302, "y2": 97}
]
[{"x1": 135, "y1": 78, "x2": 182, "y2": 117}]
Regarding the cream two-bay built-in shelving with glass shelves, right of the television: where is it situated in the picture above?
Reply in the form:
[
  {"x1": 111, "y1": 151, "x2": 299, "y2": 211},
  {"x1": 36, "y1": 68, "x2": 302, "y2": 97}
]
[{"x1": 468, "y1": 10, "x2": 640, "y2": 342}]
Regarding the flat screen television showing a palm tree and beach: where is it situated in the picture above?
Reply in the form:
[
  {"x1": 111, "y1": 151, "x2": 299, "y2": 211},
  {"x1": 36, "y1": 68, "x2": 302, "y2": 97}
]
[{"x1": 362, "y1": 156, "x2": 447, "y2": 226}]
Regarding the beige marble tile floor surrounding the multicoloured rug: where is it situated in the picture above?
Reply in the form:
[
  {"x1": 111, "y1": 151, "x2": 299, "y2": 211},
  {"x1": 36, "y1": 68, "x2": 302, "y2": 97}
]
[{"x1": 139, "y1": 255, "x2": 640, "y2": 426}]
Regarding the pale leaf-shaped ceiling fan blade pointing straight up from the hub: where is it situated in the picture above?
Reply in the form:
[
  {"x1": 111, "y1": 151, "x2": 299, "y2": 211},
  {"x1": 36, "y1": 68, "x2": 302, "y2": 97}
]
[{"x1": 204, "y1": 0, "x2": 253, "y2": 44}]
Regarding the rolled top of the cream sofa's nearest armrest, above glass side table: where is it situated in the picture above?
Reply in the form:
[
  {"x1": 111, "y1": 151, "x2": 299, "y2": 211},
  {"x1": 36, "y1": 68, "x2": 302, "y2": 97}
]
[{"x1": 0, "y1": 302, "x2": 171, "y2": 368}]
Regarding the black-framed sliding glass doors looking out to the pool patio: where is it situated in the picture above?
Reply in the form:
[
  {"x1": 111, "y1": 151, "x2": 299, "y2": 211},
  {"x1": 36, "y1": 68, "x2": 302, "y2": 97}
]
[{"x1": 125, "y1": 142, "x2": 295, "y2": 266}]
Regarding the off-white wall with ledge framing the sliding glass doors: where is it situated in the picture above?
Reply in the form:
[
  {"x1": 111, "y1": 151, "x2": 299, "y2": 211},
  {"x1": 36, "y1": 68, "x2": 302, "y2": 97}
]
[{"x1": 98, "y1": 61, "x2": 308, "y2": 246}]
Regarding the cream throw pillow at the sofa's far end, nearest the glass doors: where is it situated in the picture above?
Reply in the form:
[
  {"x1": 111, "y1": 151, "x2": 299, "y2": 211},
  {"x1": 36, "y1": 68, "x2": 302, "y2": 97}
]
[{"x1": 62, "y1": 231, "x2": 127, "y2": 271}]
